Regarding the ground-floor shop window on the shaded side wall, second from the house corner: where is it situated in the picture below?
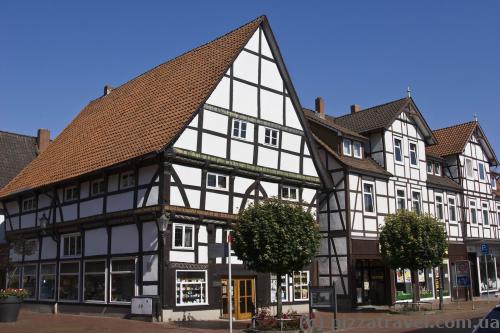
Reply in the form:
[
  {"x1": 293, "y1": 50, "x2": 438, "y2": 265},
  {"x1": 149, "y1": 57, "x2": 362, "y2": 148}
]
[{"x1": 83, "y1": 260, "x2": 106, "y2": 302}]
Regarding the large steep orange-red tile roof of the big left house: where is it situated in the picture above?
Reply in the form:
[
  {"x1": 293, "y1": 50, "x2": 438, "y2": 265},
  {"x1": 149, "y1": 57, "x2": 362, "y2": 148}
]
[{"x1": 0, "y1": 16, "x2": 266, "y2": 197}]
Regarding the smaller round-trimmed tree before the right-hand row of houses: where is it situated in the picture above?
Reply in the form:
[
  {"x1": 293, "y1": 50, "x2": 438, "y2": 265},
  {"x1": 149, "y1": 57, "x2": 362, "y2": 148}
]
[{"x1": 379, "y1": 210, "x2": 448, "y2": 303}]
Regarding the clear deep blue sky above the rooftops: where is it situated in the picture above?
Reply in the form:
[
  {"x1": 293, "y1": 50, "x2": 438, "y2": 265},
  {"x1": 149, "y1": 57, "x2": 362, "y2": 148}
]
[{"x1": 0, "y1": 0, "x2": 500, "y2": 149}]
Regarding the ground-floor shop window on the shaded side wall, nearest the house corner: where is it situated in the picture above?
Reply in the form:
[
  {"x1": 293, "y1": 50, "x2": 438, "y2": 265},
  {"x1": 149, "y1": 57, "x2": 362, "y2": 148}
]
[{"x1": 109, "y1": 258, "x2": 136, "y2": 303}]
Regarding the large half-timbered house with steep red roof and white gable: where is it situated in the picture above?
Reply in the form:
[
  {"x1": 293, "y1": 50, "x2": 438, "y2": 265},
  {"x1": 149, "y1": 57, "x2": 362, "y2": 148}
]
[{"x1": 0, "y1": 17, "x2": 331, "y2": 320}]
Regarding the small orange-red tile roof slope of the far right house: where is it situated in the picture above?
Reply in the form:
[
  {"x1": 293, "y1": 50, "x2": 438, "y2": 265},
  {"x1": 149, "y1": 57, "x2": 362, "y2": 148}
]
[{"x1": 425, "y1": 121, "x2": 477, "y2": 156}]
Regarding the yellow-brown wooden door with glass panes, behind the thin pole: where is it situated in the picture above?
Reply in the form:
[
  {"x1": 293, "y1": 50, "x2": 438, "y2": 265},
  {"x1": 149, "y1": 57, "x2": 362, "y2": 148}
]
[{"x1": 221, "y1": 278, "x2": 255, "y2": 319}]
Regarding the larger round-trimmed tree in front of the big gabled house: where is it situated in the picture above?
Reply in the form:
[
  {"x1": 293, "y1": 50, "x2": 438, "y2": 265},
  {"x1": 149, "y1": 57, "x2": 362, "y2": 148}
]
[{"x1": 232, "y1": 198, "x2": 320, "y2": 317}]
